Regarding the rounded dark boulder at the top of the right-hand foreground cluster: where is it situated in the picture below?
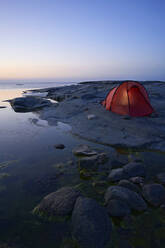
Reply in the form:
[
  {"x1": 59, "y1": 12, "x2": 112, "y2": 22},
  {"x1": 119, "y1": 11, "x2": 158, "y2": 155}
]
[{"x1": 123, "y1": 162, "x2": 145, "y2": 178}]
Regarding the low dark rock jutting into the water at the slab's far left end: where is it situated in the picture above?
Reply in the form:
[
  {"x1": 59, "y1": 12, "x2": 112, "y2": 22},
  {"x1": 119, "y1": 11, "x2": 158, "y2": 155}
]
[{"x1": 9, "y1": 96, "x2": 52, "y2": 112}]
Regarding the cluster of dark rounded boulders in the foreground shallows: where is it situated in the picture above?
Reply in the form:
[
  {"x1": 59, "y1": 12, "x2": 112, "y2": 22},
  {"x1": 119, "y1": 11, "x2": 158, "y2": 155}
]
[{"x1": 30, "y1": 145, "x2": 165, "y2": 248}]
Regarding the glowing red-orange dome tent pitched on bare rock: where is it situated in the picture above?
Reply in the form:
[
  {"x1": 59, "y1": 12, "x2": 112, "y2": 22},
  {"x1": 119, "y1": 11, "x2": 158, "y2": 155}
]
[{"x1": 102, "y1": 81, "x2": 154, "y2": 116}]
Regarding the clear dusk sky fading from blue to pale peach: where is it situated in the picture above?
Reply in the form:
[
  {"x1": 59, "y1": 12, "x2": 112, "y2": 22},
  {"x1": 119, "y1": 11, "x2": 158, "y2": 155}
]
[{"x1": 0, "y1": 0, "x2": 165, "y2": 82}]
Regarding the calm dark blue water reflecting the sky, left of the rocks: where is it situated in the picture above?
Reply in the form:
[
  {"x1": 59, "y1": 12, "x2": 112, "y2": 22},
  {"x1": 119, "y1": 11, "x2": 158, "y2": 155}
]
[{"x1": 0, "y1": 84, "x2": 165, "y2": 248}]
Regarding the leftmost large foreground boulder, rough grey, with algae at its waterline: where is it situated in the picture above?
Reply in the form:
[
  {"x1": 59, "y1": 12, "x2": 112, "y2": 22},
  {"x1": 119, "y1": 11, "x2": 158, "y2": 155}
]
[{"x1": 34, "y1": 187, "x2": 80, "y2": 217}]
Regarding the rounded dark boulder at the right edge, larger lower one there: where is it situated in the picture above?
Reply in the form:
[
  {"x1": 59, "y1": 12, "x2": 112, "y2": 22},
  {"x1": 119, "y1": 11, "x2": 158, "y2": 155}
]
[{"x1": 143, "y1": 183, "x2": 165, "y2": 207}]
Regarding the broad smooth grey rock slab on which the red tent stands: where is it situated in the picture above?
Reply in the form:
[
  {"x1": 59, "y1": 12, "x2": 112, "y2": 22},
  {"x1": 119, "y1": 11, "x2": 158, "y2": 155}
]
[{"x1": 11, "y1": 81, "x2": 165, "y2": 152}]
